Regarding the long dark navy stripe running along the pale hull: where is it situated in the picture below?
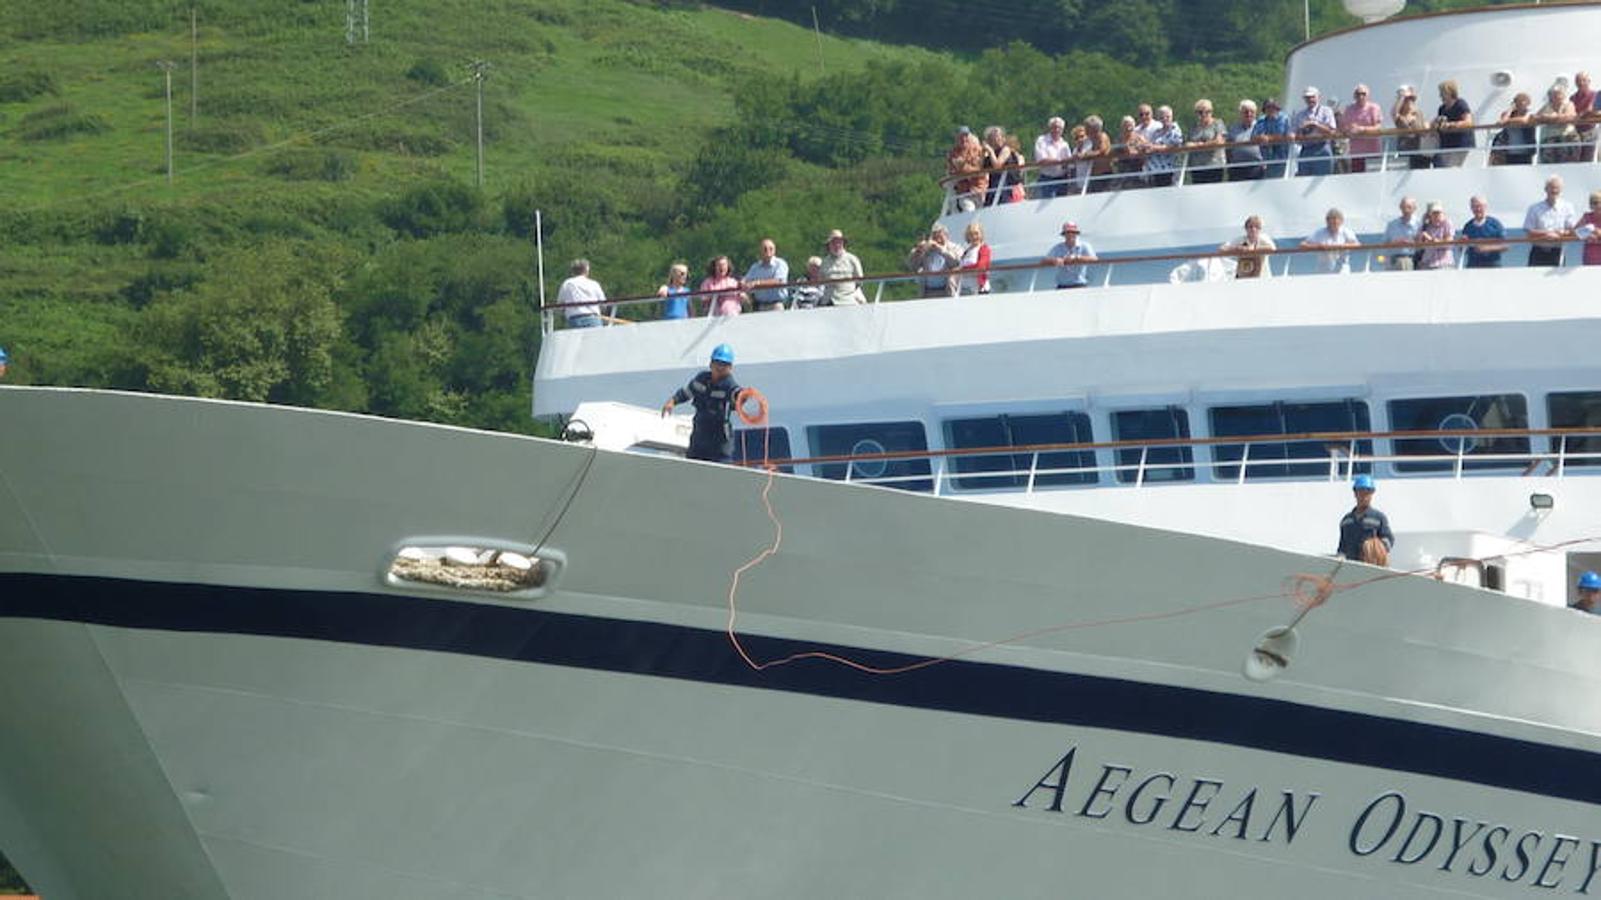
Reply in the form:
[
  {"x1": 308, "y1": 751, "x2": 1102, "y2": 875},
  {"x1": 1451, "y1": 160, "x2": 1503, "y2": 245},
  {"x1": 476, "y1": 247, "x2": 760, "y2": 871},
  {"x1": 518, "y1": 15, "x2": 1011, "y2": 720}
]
[{"x1": 0, "y1": 575, "x2": 1601, "y2": 804}]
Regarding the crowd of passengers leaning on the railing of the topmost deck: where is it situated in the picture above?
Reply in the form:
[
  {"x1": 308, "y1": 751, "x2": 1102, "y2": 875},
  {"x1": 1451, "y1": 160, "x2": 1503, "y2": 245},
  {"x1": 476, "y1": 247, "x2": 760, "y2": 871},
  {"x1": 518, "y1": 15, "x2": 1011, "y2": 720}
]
[{"x1": 946, "y1": 72, "x2": 1601, "y2": 210}]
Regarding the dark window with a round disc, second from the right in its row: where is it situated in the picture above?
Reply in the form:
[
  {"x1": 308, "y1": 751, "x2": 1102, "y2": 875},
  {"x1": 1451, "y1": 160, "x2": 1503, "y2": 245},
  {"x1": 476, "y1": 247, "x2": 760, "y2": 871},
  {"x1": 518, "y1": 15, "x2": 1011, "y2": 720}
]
[{"x1": 1390, "y1": 394, "x2": 1529, "y2": 472}]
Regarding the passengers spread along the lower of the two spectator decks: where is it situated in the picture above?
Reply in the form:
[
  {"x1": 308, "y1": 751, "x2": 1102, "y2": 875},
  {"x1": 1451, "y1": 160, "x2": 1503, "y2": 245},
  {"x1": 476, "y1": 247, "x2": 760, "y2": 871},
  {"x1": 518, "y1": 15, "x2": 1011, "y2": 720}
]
[{"x1": 556, "y1": 175, "x2": 1601, "y2": 321}]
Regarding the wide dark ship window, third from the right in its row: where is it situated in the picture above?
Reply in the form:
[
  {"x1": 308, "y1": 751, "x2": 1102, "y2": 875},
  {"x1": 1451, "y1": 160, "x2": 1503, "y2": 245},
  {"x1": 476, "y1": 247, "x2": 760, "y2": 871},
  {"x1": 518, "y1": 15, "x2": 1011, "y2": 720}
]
[{"x1": 1209, "y1": 400, "x2": 1374, "y2": 480}]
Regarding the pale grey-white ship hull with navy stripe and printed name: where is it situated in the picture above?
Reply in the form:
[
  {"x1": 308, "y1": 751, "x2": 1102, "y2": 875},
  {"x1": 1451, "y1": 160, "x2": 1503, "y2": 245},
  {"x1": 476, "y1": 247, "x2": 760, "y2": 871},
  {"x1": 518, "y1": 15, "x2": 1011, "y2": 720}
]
[{"x1": 0, "y1": 389, "x2": 1601, "y2": 900}]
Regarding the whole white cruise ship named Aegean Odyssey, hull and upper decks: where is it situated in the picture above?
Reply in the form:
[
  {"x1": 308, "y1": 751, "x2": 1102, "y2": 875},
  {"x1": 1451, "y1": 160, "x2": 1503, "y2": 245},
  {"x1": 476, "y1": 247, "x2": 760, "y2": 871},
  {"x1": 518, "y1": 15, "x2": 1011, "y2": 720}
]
[{"x1": 0, "y1": 3, "x2": 1601, "y2": 900}]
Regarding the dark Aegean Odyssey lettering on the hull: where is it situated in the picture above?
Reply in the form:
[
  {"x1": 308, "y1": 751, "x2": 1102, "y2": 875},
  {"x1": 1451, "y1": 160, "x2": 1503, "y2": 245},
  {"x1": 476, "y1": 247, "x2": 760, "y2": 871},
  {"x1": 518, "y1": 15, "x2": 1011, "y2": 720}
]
[{"x1": 1012, "y1": 746, "x2": 1601, "y2": 895}]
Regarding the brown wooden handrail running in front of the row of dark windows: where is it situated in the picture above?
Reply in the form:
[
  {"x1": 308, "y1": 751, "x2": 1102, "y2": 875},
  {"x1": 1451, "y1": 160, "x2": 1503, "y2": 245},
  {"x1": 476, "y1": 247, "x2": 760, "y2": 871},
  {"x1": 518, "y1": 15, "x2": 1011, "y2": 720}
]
[{"x1": 740, "y1": 426, "x2": 1601, "y2": 474}]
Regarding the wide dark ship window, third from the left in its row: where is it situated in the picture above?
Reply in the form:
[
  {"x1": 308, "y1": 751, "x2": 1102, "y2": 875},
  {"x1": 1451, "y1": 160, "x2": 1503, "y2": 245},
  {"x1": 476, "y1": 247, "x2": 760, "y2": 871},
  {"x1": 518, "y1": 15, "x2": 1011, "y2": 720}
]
[{"x1": 945, "y1": 413, "x2": 1097, "y2": 490}]
